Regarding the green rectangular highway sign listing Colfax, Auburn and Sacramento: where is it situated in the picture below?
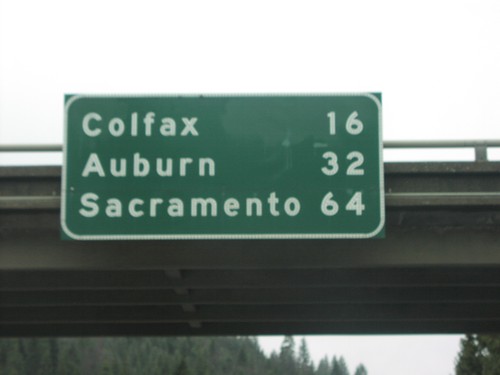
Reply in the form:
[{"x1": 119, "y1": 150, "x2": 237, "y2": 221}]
[{"x1": 61, "y1": 93, "x2": 384, "y2": 240}]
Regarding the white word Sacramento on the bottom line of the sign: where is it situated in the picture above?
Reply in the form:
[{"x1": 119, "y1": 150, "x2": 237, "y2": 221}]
[{"x1": 78, "y1": 191, "x2": 301, "y2": 218}]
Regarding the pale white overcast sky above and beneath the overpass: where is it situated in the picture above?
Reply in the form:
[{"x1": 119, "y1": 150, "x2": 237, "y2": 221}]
[{"x1": 0, "y1": 0, "x2": 500, "y2": 375}]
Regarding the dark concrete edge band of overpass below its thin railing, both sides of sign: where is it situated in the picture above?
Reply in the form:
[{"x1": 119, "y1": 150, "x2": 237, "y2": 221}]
[{"x1": 0, "y1": 162, "x2": 500, "y2": 211}]
